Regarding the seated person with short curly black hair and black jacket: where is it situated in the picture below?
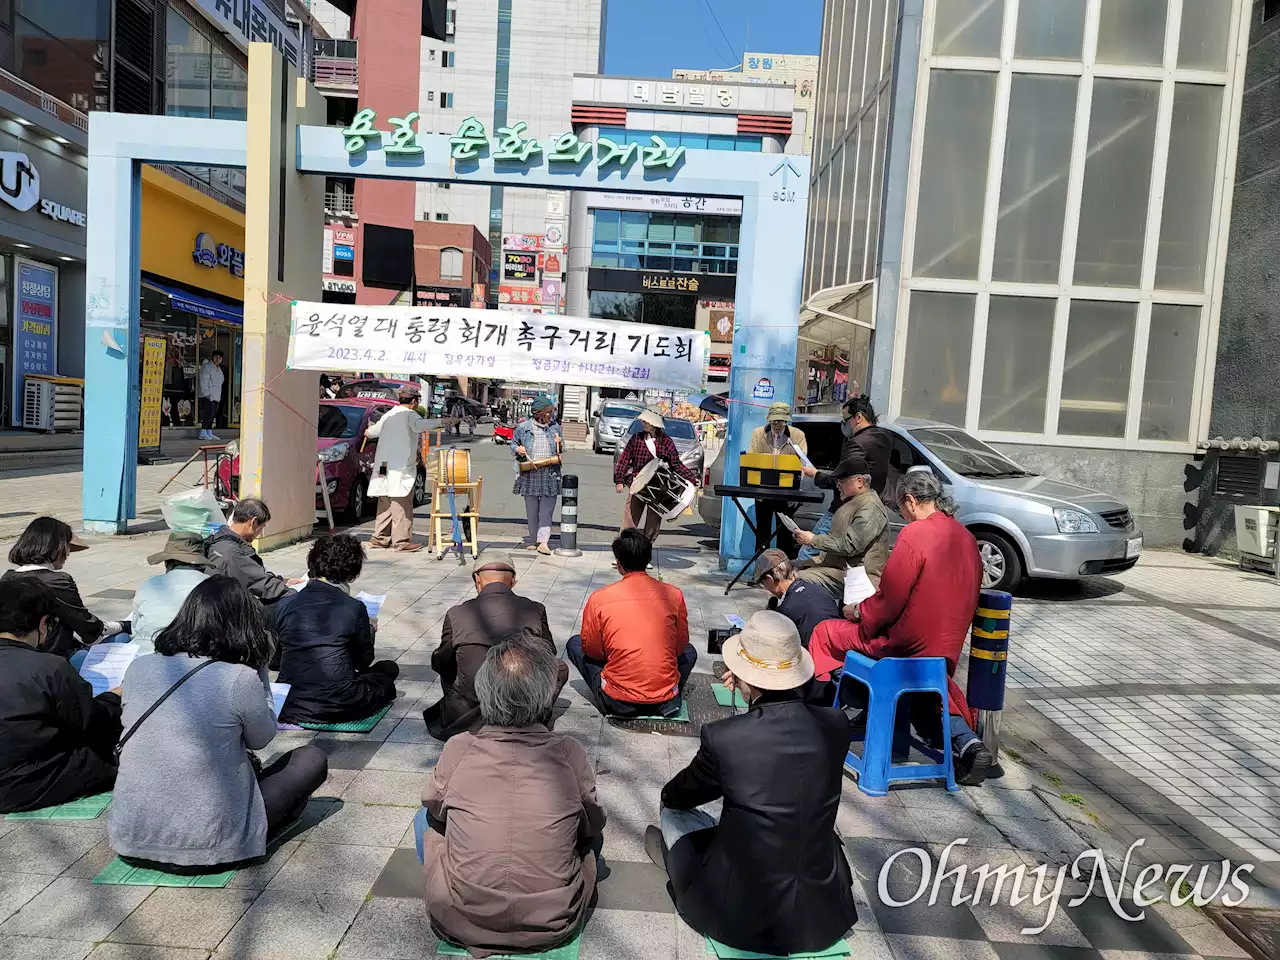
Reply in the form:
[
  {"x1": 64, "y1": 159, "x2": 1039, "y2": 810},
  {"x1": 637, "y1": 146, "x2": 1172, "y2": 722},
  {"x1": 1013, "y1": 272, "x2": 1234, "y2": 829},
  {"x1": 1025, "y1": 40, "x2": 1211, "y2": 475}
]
[{"x1": 275, "y1": 534, "x2": 399, "y2": 723}]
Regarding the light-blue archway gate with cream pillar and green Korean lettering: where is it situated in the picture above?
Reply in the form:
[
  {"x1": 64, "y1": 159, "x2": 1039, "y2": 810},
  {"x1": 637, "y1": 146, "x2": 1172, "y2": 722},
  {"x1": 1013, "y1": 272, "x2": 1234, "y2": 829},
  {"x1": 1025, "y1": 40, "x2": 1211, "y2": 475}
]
[{"x1": 83, "y1": 44, "x2": 809, "y2": 572}]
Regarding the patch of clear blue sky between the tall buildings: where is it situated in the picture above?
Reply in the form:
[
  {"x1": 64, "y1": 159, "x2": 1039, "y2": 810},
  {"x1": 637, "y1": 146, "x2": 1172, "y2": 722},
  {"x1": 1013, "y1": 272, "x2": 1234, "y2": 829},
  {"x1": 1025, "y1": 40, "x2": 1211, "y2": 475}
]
[{"x1": 604, "y1": 0, "x2": 822, "y2": 77}]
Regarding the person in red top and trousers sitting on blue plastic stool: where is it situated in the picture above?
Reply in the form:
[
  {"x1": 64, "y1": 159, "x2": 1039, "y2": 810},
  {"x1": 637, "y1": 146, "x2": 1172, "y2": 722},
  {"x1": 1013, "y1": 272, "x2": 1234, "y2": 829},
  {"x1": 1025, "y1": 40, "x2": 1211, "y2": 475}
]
[{"x1": 810, "y1": 472, "x2": 992, "y2": 786}]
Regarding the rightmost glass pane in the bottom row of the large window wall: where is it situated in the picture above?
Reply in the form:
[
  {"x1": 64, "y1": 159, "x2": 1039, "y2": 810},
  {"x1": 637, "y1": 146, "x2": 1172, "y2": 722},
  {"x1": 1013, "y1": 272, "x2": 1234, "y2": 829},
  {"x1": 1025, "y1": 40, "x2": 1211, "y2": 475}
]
[{"x1": 1138, "y1": 303, "x2": 1201, "y2": 440}]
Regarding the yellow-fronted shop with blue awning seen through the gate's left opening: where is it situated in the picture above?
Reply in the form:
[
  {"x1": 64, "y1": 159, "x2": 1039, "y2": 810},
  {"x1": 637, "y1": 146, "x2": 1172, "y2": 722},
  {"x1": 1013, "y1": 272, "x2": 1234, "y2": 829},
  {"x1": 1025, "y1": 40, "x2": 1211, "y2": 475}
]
[{"x1": 140, "y1": 166, "x2": 244, "y2": 428}]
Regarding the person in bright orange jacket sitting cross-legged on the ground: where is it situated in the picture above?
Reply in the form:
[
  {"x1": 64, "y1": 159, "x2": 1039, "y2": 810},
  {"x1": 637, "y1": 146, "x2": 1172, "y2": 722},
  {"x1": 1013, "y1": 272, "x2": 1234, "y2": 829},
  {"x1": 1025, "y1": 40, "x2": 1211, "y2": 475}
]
[{"x1": 564, "y1": 527, "x2": 698, "y2": 718}]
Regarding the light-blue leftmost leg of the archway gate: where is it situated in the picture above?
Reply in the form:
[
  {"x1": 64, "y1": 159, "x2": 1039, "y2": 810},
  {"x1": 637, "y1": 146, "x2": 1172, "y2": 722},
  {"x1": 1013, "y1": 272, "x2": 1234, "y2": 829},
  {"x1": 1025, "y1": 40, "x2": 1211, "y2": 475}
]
[{"x1": 82, "y1": 145, "x2": 142, "y2": 534}]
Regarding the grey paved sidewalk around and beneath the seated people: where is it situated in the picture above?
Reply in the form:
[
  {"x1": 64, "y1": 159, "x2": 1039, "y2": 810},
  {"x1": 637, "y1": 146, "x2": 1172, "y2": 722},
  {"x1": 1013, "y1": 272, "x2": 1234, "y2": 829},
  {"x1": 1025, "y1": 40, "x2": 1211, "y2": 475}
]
[{"x1": 0, "y1": 535, "x2": 1264, "y2": 960}]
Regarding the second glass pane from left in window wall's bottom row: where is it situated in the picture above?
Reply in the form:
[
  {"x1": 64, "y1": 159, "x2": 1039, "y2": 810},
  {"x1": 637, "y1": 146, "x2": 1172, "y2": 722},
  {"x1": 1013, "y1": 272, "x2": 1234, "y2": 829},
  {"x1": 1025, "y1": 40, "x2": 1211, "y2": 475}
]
[{"x1": 978, "y1": 297, "x2": 1057, "y2": 434}]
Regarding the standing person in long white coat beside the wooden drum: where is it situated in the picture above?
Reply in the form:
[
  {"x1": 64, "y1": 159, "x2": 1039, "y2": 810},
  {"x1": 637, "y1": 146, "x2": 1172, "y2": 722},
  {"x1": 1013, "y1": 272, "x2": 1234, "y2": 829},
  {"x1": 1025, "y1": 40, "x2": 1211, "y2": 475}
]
[{"x1": 365, "y1": 384, "x2": 430, "y2": 553}]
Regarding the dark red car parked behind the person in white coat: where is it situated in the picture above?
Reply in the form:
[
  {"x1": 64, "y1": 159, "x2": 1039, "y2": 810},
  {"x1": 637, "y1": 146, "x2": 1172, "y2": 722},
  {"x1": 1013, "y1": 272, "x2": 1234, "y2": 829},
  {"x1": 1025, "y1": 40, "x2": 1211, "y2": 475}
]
[{"x1": 218, "y1": 398, "x2": 428, "y2": 524}]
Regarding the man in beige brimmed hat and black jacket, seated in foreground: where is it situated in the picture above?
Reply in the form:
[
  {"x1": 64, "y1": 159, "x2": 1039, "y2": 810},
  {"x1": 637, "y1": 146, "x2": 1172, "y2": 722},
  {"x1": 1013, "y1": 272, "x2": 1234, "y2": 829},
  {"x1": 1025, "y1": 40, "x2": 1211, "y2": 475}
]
[{"x1": 646, "y1": 611, "x2": 858, "y2": 956}]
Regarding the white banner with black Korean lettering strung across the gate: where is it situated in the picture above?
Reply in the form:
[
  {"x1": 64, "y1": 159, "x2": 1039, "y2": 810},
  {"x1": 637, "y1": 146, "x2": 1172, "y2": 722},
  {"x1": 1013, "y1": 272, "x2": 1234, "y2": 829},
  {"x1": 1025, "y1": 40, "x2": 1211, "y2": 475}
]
[{"x1": 289, "y1": 302, "x2": 710, "y2": 390}]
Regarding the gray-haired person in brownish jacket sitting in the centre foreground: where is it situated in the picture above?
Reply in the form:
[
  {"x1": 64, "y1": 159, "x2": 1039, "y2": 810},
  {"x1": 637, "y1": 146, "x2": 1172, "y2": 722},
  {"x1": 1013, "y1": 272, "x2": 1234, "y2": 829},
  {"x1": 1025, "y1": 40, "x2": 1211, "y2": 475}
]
[{"x1": 413, "y1": 636, "x2": 604, "y2": 952}]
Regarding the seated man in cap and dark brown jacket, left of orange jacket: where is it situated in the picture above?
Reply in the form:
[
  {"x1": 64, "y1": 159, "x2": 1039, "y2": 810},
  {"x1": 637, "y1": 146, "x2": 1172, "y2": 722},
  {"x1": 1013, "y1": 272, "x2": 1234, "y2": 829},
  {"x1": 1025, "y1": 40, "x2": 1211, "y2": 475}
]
[{"x1": 422, "y1": 550, "x2": 568, "y2": 740}]
